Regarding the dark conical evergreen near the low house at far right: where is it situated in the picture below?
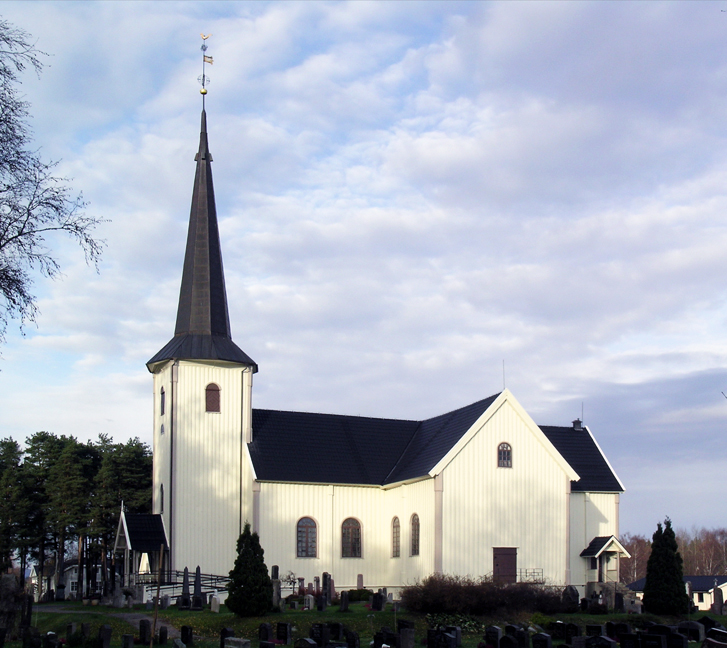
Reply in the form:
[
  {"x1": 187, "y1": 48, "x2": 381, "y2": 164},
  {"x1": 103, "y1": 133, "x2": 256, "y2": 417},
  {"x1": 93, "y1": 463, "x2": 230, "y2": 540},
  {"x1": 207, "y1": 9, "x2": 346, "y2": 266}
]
[{"x1": 644, "y1": 518, "x2": 690, "y2": 616}]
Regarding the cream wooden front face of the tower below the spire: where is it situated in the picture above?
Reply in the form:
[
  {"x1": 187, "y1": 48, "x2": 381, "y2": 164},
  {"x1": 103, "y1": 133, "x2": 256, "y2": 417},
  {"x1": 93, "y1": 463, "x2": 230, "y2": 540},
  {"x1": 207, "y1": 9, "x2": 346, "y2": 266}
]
[{"x1": 165, "y1": 361, "x2": 242, "y2": 574}]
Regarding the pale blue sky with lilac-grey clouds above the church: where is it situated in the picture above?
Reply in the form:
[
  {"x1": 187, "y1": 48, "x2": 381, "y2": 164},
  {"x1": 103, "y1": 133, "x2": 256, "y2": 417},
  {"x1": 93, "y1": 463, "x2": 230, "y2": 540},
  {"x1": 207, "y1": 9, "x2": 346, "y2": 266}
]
[{"x1": 0, "y1": 1, "x2": 727, "y2": 535}]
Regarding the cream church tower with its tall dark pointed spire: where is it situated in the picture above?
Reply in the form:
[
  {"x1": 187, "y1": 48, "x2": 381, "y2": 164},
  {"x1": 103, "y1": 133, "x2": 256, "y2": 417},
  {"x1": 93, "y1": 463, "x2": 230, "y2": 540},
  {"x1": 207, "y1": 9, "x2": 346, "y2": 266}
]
[{"x1": 147, "y1": 108, "x2": 257, "y2": 575}]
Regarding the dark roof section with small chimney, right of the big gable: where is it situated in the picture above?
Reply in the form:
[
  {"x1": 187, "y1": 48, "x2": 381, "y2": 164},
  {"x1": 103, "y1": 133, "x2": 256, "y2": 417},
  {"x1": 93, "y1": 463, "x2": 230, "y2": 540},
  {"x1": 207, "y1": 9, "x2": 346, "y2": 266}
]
[{"x1": 540, "y1": 425, "x2": 623, "y2": 493}]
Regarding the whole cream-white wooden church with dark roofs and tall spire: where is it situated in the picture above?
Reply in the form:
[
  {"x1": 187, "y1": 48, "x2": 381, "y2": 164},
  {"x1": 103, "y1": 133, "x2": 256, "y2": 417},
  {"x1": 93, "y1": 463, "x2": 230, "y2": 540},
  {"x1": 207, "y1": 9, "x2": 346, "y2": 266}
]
[{"x1": 139, "y1": 106, "x2": 626, "y2": 595}]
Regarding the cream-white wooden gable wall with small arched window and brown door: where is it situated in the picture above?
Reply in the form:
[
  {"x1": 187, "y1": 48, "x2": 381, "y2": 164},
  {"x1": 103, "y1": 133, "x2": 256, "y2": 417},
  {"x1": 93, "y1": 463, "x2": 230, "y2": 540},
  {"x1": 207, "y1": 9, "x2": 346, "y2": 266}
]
[{"x1": 442, "y1": 401, "x2": 567, "y2": 584}]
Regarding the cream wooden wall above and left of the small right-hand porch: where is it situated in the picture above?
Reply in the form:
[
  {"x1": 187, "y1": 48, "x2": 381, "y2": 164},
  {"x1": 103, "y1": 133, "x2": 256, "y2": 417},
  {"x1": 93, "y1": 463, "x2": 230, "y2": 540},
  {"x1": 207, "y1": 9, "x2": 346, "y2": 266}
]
[{"x1": 570, "y1": 493, "x2": 619, "y2": 591}]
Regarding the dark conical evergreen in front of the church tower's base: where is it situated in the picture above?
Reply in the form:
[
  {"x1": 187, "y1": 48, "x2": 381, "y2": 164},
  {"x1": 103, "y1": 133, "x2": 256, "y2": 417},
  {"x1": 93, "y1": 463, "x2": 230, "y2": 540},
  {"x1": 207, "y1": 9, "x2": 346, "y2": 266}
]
[{"x1": 226, "y1": 522, "x2": 273, "y2": 617}]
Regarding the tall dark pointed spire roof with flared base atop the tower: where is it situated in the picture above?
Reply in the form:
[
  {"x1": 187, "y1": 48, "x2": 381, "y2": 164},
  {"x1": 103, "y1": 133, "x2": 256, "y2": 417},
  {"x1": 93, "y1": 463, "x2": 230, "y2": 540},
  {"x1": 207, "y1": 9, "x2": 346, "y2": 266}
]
[{"x1": 147, "y1": 110, "x2": 257, "y2": 371}]
